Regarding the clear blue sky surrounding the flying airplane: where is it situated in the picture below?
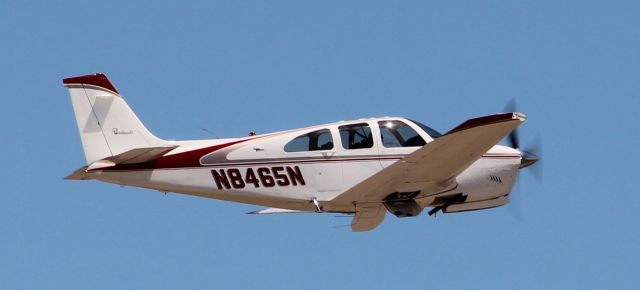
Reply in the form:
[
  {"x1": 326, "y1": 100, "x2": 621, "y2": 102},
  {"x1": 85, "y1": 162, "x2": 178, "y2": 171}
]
[{"x1": 0, "y1": 1, "x2": 640, "y2": 289}]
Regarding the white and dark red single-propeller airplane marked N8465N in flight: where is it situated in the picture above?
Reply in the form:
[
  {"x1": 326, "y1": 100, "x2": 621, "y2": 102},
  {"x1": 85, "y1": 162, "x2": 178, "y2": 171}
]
[{"x1": 63, "y1": 73, "x2": 539, "y2": 232}]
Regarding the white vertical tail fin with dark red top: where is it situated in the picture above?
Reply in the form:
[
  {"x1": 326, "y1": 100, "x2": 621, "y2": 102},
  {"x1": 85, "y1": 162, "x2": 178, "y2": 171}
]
[{"x1": 63, "y1": 73, "x2": 175, "y2": 164}]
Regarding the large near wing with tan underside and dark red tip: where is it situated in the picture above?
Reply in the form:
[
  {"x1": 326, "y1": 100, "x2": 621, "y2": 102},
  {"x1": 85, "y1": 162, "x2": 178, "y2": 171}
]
[{"x1": 332, "y1": 113, "x2": 526, "y2": 231}]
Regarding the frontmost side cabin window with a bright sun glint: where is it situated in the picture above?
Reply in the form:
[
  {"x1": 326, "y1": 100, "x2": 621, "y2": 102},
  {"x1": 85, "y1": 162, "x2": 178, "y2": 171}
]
[{"x1": 378, "y1": 120, "x2": 427, "y2": 148}]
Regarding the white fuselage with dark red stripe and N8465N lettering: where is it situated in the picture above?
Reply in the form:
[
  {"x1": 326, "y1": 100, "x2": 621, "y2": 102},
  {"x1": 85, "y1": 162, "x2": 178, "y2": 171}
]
[{"x1": 89, "y1": 118, "x2": 521, "y2": 213}]
